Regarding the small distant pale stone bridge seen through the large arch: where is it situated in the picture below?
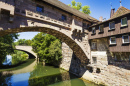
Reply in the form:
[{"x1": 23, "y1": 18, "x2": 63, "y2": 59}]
[{"x1": 15, "y1": 46, "x2": 37, "y2": 58}]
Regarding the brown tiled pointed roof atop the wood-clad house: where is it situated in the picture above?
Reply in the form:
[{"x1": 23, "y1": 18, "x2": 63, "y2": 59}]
[{"x1": 111, "y1": 6, "x2": 130, "y2": 19}]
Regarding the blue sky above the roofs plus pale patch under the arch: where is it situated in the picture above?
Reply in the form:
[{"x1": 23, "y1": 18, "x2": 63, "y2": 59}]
[{"x1": 15, "y1": 0, "x2": 130, "y2": 39}]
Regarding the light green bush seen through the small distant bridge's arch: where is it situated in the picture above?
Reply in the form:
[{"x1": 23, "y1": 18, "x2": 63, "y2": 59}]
[{"x1": 11, "y1": 50, "x2": 28, "y2": 65}]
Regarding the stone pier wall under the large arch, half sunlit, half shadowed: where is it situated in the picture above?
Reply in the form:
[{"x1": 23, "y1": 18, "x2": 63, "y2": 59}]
[{"x1": 60, "y1": 43, "x2": 83, "y2": 76}]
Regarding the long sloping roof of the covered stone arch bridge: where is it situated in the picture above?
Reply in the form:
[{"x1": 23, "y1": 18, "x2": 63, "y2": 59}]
[{"x1": 42, "y1": 0, "x2": 98, "y2": 22}]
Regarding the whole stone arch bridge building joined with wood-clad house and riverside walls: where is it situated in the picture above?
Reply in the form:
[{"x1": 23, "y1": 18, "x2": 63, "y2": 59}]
[{"x1": 0, "y1": 0, "x2": 130, "y2": 86}]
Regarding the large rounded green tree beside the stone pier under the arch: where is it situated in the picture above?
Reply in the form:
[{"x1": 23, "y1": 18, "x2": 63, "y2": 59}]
[{"x1": 32, "y1": 33, "x2": 62, "y2": 65}]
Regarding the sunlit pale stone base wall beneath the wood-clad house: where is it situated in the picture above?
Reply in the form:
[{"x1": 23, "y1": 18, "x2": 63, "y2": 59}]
[{"x1": 82, "y1": 65, "x2": 130, "y2": 86}]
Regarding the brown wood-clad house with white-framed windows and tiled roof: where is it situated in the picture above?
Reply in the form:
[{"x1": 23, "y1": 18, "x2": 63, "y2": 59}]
[{"x1": 89, "y1": 6, "x2": 130, "y2": 69}]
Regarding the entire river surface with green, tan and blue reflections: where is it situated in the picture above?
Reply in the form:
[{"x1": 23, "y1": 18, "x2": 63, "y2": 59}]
[{"x1": 0, "y1": 61, "x2": 98, "y2": 86}]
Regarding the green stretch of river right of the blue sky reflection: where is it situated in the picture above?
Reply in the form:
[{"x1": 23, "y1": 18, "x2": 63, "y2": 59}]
[{"x1": 28, "y1": 62, "x2": 97, "y2": 86}]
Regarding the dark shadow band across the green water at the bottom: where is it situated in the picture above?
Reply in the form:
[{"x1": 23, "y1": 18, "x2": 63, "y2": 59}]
[{"x1": 28, "y1": 72, "x2": 77, "y2": 86}]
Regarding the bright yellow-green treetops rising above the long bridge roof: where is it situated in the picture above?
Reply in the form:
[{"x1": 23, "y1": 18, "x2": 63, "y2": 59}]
[{"x1": 68, "y1": 0, "x2": 91, "y2": 15}]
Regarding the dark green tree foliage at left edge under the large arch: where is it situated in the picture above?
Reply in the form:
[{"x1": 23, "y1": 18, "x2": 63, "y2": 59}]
[{"x1": 0, "y1": 34, "x2": 19, "y2": 65}]
